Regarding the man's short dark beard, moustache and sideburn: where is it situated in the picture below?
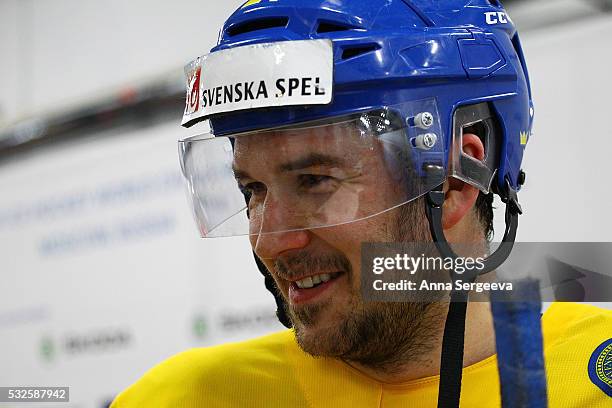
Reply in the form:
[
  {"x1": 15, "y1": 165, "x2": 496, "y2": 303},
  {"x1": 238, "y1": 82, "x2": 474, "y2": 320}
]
[{"x1": 276, "y1": 199, "x2": 444, "y2": 374}]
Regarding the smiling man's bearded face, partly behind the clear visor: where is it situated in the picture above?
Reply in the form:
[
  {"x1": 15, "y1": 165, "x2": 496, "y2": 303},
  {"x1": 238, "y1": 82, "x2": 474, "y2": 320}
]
[{"x1": 233, "y1": 123, "x2": 440, "y2": 365}]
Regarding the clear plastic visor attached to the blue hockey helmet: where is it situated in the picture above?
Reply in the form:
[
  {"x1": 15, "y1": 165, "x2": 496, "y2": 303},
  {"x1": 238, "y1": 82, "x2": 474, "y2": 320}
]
[{"x1": 179, "y1": 99, "x2": 447, "y2": 237}]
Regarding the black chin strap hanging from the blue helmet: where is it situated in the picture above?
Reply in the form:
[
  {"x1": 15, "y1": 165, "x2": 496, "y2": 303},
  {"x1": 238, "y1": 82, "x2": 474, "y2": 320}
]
[{"x1": 425, "y1": 180, "x2": 522, "y2": 408}]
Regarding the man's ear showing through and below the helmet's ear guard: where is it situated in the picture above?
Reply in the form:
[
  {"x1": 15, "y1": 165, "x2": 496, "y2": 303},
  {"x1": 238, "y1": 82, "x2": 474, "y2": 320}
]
[{"x1": 442, "y1": 133, "x2": 484, "y2": 230}]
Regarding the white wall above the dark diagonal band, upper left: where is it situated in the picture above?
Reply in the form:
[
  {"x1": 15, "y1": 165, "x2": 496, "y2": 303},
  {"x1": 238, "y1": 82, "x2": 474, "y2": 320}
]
[{"x1": 0, "y1": 0, "x2": 242, "y2": 123}]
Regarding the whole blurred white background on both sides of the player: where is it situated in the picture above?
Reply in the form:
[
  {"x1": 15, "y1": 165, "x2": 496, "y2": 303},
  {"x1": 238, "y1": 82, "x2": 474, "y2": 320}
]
[{"x1": 0, "y1": 0, "x2": 612, "y2": 408}]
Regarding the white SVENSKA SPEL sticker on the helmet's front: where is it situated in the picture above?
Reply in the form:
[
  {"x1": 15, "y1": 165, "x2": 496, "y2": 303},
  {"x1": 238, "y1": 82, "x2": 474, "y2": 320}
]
[{"x1": 182, "y1": 40, "x2": 334, "y2": 124}]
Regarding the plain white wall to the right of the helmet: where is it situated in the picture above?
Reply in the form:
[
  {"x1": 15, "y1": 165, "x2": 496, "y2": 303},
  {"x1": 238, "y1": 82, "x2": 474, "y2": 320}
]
[{"x1": 512, "y1": 15, "x2": 612, "y2": 241}]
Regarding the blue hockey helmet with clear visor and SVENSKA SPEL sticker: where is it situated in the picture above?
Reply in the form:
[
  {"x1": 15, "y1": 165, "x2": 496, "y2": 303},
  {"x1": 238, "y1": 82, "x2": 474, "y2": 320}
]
[{"x1": 180, "y1": 0, "x2": 533, "y2": 237}]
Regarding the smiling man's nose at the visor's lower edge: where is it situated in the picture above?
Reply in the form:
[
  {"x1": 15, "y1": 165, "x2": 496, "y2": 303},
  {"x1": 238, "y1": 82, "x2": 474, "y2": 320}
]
[{"x1": 250, "y1": 191, "x2": 310, "y2": 259}]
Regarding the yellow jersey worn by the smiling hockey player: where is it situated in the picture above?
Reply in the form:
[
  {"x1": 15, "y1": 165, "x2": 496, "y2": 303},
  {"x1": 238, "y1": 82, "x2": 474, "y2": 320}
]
[{"x1": 111, "y1": 303, "x2": 612, "y2": 408}]
